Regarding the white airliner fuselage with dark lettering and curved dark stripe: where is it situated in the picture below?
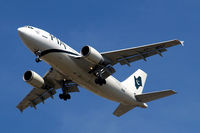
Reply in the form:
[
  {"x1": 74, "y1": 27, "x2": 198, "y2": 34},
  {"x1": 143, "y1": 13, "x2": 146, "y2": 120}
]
[{"x1": 18, "y1": 26, "x2": 142, "y2": 106}]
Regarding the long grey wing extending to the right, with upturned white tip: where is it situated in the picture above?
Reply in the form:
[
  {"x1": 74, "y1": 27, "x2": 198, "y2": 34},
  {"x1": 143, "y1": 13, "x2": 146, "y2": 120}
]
[{"x1": 101, "y1": 40, "x2": 183, "y2": 65}]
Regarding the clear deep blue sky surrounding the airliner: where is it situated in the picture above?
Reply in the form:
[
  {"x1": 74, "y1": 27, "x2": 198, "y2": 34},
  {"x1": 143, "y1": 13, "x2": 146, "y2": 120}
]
[{"x1": 0, "y1": 0, "x2": 200, "y2": 133}]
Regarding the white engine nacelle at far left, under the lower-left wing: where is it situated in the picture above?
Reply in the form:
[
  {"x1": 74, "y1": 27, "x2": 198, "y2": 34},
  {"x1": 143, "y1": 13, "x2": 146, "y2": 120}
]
[{"x1": 23, "y1": 71, "x2": 45, "y2": 88}]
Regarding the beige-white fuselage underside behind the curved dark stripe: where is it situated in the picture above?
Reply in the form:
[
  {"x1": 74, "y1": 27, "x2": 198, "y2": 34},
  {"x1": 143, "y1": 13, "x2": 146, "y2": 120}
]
[{"x1": 43, "y1": 53, "x2": 132, "y2": 104}]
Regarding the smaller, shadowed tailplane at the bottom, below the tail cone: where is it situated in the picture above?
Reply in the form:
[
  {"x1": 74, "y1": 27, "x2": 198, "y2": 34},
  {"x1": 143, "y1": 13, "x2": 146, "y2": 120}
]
[{"x1": 113, "y1": 103, "x2": 136, "y2": 117}]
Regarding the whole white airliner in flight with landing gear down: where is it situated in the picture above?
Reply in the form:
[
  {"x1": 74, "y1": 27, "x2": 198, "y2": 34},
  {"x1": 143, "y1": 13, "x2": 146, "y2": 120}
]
[{"x1": 17, "y1": 26, "x2": 183, "y2": 117}]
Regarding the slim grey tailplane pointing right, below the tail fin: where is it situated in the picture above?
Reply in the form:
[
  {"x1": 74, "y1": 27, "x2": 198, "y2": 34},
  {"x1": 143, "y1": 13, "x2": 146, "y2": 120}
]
[{"x1": 135, "y1": 90, "x2": 176, "y2": 103}]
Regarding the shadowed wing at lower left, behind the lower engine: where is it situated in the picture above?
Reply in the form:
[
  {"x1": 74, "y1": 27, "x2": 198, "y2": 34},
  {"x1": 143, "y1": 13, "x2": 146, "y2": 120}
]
[{"x1": 17, "y1": 68, "x2": 79, "y2": 112}]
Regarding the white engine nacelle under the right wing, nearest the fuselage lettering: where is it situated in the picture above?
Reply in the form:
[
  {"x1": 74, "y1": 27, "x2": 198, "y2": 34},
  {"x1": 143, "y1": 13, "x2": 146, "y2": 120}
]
[{"x1": 81, "y1": 46, "x2": 104, "y2": 65}]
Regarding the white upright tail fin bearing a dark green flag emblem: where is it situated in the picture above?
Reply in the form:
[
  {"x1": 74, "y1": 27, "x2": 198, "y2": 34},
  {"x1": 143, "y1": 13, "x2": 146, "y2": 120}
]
[{"x1": 122, "y1": 69, "x2": 147, "y2": 94}]
